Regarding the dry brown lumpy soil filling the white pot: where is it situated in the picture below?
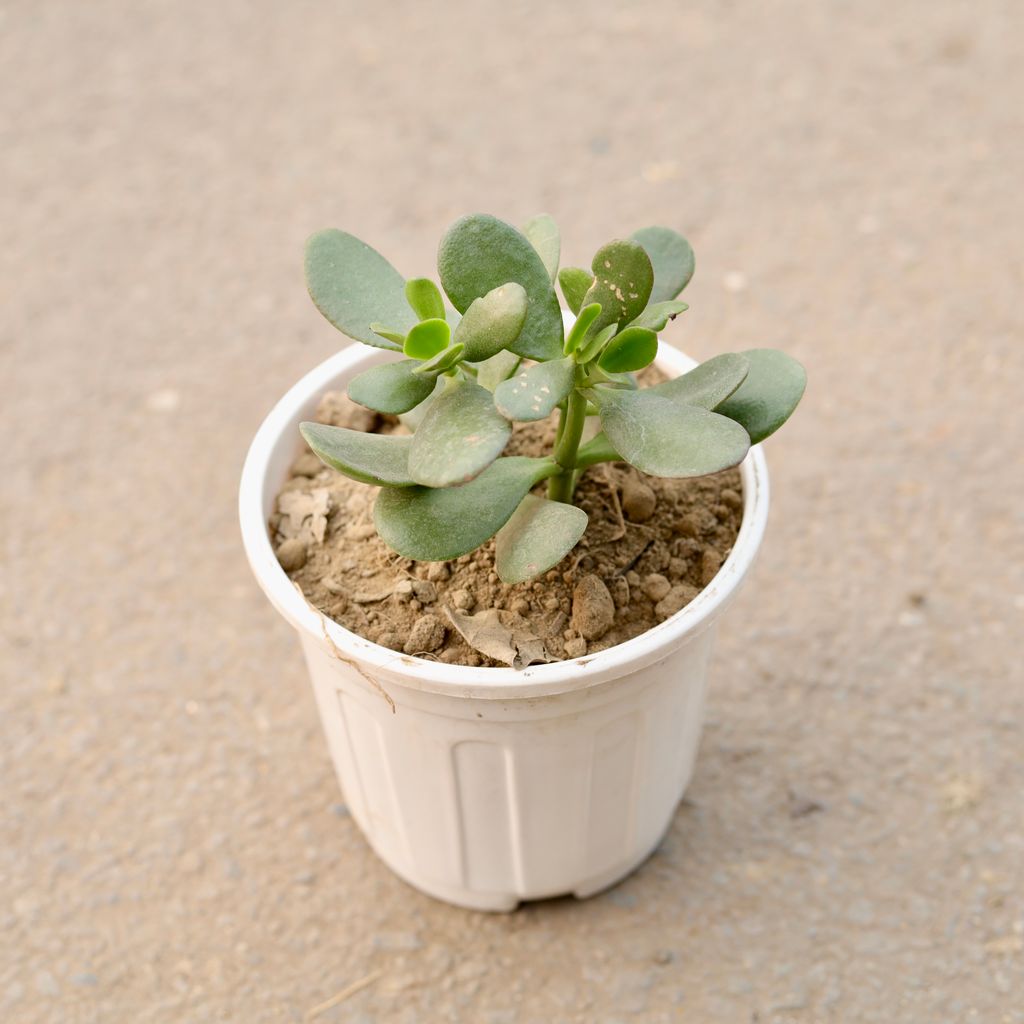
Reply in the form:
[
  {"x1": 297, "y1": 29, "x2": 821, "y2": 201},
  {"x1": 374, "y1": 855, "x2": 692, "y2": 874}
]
[{"x1": 269, "y1": 382, "x2": 742, "y2": 667}]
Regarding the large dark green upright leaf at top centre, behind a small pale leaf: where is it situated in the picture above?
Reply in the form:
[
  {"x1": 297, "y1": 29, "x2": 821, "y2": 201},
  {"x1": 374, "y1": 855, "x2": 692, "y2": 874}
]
[{"x1": 437, "y1": 214, "x2": 562, "y2": 359}]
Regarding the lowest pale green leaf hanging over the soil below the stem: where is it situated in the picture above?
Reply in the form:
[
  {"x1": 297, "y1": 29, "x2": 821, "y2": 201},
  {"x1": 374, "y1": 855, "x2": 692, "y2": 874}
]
[{"x1": 495, "y1": 495, "x2": 587, "y2": 585}]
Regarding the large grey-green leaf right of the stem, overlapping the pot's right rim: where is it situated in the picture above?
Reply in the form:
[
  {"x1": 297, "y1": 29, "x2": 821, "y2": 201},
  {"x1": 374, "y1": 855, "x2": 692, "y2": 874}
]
[{"x1": 588, "y1": 387, "x2": 751, "y2": 477}]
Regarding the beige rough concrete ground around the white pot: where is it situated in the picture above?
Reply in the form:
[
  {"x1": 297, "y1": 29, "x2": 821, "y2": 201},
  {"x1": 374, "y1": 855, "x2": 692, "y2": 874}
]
[{"x1": 0, "y1": 0, "x2": 1024, "y2": 1024}]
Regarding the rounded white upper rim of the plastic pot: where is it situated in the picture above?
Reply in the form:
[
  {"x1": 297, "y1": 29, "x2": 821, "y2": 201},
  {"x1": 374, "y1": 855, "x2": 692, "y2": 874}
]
[{"x1": 239, "y1": 341, "x2": 769, "y2": 699}]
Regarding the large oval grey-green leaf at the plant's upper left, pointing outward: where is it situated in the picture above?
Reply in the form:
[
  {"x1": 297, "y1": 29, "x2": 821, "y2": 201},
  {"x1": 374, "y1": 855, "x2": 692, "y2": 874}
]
[{"x1": 306, "y1": 228, "x2": 417, "y2": 348}]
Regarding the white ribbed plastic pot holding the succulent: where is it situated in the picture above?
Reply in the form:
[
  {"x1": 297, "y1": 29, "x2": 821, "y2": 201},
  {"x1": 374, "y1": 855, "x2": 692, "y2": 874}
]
[{"x1": 240, "y1": 342, "x2": 768, "y2": 910}]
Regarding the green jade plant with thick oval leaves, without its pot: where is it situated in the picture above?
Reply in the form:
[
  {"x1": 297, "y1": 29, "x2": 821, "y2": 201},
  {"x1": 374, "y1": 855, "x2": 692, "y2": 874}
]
[{"x1": 300, "y1": 214, "x2": 805, "y2": 584}]
